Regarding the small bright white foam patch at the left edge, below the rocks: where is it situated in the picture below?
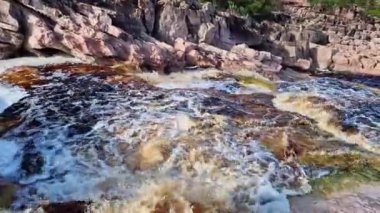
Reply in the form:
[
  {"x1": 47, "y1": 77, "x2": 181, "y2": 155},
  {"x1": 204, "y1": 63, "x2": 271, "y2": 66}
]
[{"x1": 0, "y1": 83, "x2": 28, "y2": 113}]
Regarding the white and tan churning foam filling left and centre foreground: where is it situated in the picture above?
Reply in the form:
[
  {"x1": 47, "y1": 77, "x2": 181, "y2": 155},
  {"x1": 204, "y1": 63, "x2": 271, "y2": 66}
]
[{"x1": 0, "y1": 71, "x2": 302, "y2": 212}]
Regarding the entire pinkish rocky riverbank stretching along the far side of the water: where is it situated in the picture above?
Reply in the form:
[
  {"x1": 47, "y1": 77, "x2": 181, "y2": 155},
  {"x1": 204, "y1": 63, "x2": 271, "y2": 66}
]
[{"x1": 0, "y1": 0, "x2": 380, "y2": 76}]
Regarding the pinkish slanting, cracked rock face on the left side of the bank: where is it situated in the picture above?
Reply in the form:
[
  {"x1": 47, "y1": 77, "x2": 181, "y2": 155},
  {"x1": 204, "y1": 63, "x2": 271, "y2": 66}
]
[{"x1": 0, "y1": 0, "x2": 279, "y2": 75}]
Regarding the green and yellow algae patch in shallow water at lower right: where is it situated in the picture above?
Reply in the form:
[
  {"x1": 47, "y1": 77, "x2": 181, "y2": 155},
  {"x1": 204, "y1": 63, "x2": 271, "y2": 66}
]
[{"x1": 300, "y1": 153, "x2": 380, "y2": 196}]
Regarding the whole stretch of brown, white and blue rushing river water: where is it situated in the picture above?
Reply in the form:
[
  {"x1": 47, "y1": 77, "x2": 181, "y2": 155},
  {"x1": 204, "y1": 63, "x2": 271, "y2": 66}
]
[{"x1": 0, "y1": 64, "x2": 380, "y2": 212}]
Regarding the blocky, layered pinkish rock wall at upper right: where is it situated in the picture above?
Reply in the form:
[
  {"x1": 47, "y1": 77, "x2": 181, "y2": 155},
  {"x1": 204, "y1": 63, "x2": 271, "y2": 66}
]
[{"x1": 261, "y1": 6, "x2": 380, "y2": 76}]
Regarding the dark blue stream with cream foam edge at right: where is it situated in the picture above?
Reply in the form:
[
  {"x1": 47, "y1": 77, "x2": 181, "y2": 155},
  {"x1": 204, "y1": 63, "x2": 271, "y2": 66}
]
[{"x1": 274, "y1": 78, "x2": 380, "y2": 152}]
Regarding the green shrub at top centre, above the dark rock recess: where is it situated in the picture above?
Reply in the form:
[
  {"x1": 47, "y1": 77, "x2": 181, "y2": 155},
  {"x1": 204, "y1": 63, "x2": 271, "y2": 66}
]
[{"x1": 203, "y1": 0, "x2": 279, "y2": 15}]
